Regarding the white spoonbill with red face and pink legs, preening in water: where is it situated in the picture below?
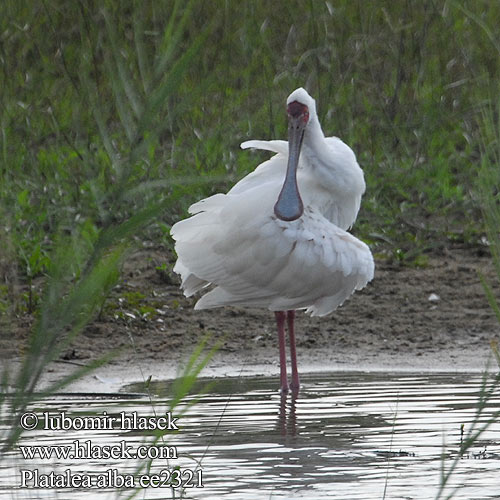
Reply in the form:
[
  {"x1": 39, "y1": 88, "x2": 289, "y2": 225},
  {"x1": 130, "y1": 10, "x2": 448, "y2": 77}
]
[{"x1": 171, "y1": 88, "x2": 374, "y2": 392}]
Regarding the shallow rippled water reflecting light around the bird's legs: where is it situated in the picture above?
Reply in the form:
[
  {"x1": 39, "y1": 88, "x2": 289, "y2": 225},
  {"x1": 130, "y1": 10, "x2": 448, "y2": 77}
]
[{"x1": 0, "y1": 373, "x2": 500, "y2": 500}]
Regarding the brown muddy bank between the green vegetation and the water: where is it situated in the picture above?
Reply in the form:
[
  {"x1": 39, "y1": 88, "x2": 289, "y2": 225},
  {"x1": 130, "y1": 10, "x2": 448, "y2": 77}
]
[{"x1": 0, "y1": 244, "x2": 500, "y2": 390}]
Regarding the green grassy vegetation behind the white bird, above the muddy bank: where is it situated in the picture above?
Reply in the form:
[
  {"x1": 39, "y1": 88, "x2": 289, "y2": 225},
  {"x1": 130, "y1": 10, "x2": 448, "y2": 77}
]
[{"x1": 0, "y1": 0, "x2": 500, "y2": 329}]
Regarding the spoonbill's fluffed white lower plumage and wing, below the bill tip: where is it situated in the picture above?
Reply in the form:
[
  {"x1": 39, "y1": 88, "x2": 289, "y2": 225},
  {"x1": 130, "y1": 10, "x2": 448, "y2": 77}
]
[{"x1": 172, "y1": 187, "x2": 374, "y2": 315}]
